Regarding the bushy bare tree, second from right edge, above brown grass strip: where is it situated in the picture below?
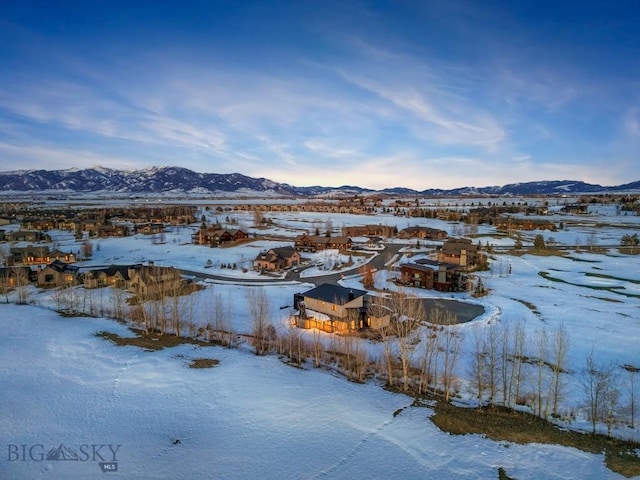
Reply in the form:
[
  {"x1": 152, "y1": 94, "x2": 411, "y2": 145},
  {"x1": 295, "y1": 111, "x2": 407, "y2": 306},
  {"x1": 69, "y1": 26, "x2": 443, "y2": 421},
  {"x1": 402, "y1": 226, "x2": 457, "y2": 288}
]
[{"x1": 578, "y1": 349, "x2": 616, "y2": 434}]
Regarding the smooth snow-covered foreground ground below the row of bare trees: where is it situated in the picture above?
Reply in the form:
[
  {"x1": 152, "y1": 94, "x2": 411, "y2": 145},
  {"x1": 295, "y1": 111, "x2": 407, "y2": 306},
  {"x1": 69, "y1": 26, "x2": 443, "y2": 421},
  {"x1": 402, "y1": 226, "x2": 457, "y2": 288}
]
[{"x1": 0, "y1": 305, "x2": 621, "y2": 480}]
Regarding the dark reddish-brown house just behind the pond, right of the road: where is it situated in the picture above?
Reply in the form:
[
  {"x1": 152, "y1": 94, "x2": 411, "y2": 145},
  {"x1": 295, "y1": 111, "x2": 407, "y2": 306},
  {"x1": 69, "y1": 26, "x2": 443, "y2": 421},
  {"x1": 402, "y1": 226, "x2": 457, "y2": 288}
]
[{"x1": 400, "y1": 259, "x2": 463, "y2": 292}]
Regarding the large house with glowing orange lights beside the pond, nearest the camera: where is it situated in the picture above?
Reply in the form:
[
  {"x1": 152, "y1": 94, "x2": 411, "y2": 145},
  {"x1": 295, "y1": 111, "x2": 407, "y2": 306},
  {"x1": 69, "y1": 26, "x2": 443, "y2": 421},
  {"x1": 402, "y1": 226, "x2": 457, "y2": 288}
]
[{"x1": 294, "y1": 283, "x2": 390, "y2": 333}]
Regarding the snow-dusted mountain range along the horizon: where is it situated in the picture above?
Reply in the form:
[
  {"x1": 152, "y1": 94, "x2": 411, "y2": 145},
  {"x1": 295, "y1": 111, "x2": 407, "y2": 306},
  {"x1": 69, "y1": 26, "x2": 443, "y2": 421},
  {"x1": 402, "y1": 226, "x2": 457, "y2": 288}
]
[{"x1": 0, "y1": 167, "x2": 640, "y2": 197}]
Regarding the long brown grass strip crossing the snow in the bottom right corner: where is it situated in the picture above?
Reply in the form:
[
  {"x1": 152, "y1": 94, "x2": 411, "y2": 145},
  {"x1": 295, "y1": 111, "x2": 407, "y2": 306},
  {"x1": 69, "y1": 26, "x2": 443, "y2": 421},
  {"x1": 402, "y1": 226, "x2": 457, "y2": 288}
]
[{"x1": 431, "y1": 401, "x2": 640, "y2": 477}]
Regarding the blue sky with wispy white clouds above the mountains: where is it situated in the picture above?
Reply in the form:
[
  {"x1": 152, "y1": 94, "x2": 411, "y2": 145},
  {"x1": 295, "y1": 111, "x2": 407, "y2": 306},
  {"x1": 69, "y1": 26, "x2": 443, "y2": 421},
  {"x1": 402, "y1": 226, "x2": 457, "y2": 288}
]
[{"x1": 0, "y1": 0, "x2": 640, "y2": 190}]
